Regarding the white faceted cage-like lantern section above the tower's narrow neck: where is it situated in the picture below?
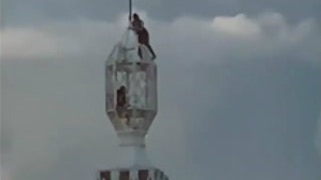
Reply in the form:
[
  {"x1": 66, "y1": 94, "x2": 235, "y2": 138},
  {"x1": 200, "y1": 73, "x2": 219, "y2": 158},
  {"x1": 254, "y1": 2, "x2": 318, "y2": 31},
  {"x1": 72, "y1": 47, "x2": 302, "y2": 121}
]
[{"x1": 105, "y1": 29, "x2": 157, "y2": 134}]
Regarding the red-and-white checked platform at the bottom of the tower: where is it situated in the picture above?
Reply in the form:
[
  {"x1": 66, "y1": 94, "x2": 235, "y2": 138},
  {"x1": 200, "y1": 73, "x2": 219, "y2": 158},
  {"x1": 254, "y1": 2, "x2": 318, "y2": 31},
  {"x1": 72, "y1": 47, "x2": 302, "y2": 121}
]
[{"x1": 98, "y1": 168, "x2": 169, "y2": 180}]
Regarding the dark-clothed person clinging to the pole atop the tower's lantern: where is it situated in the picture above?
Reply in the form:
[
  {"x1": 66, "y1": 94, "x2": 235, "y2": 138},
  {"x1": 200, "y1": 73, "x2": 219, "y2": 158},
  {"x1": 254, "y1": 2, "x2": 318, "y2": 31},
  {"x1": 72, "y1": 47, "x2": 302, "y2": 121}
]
[{"x1": 130, "y1": 13, "x2": 156, "y2": 60}]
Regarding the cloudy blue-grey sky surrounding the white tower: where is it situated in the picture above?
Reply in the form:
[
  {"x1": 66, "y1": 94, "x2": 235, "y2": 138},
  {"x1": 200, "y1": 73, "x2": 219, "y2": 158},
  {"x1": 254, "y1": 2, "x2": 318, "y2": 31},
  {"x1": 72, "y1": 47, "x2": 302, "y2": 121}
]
[{"x1": 0, "y1": 0, "x2": 321, "y2": 180}]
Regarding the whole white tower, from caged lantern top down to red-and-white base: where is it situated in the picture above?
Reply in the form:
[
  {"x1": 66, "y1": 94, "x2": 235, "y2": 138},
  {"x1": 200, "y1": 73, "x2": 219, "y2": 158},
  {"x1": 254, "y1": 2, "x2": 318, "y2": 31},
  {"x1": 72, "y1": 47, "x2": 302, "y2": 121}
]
[{"x1": 99, "y1": 26, "x2": 168, "y2": 180}]
